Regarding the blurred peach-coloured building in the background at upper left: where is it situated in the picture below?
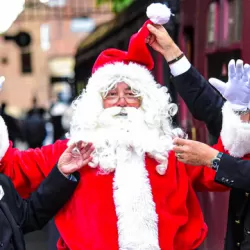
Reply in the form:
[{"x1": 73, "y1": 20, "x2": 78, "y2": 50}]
[{"x1": 0, "y1": 0, "x2": 114, "y2": 116}]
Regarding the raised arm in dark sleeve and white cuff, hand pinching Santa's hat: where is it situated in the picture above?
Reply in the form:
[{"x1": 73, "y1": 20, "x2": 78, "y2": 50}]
[{"x1": 147, "y1": 25, "x2": 224, "y2": 137}]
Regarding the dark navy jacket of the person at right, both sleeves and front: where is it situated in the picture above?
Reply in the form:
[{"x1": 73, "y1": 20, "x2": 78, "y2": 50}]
[{"x1": 172, "y1": 67, "x2": 250, "y2": 250}]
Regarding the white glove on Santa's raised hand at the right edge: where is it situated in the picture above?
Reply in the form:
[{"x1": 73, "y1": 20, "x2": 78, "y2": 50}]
[{"x1": 209, "y1": 60, "x2": 250, "y2": 111}]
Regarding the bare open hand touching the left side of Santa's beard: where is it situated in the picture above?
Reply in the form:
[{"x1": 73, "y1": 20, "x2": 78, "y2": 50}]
[{"x1": 57, "y1": 141, "x2": 94, "y2": 176}]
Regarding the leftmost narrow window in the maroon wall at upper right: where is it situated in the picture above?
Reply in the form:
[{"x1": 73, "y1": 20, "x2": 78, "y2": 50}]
[{"x1": 207, "y1": 1, "x2": 219, "y2": 44}]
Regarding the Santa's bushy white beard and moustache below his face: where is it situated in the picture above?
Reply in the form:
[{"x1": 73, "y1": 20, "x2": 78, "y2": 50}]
[{"x1": 69, "y1": 107, "x2": 175, "y2": 174}]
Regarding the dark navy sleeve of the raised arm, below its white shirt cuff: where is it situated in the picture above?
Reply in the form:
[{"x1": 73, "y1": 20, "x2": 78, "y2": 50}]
[{"x1": 172, "y1": 66, "x2": 224, "y2": 138}]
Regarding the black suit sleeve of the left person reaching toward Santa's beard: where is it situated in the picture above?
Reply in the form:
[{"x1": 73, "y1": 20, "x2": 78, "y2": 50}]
[{"x1": 16, "y1": 167, "x2": 79, "y2": 233}]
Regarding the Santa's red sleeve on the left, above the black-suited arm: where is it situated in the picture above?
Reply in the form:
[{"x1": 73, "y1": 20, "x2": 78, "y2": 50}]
[{"x1": 0, "y1": 140, "x2": 67, "y2": 197}]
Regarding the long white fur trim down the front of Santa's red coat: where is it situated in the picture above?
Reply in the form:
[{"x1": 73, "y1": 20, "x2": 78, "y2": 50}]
[{"x1": 113, "y1": 148, "x2": 160, "y2": 250}]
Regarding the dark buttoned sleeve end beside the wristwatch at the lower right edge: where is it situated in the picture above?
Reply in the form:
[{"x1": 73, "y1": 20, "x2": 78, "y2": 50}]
[{"x1": 215, "y1": 154, "x2": 250, "y2": 192}]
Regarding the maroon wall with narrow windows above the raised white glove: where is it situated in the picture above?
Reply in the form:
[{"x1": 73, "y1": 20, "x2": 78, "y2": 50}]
[{"x1": 179, "y1": 0, "x2": 250, "y2": 78}]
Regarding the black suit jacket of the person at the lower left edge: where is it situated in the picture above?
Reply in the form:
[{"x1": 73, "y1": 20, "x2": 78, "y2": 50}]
[{"x1": 0, "y1": 167, "x2": 79, "y2": 250}]
